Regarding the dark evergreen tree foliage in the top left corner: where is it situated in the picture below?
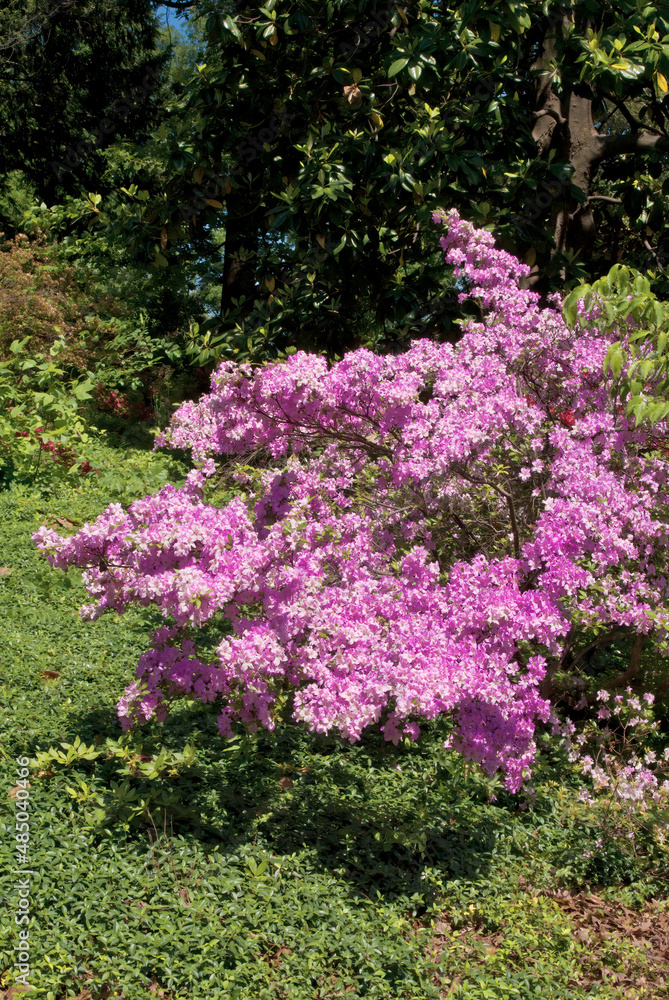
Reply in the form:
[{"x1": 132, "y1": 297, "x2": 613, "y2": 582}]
[{"x1": 0, "y1": 0, "x2": 165, "y2": 225}]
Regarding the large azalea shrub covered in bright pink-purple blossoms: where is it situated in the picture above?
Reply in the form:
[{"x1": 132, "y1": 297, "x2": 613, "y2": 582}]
[{"x1": 35, "y1": 212, "x2": 668, "y2": 790}]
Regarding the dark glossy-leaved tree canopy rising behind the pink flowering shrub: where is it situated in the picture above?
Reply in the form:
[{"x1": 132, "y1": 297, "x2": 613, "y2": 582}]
[{"x1": 4, "y1": 0, "x2": 669, "y2": 361}]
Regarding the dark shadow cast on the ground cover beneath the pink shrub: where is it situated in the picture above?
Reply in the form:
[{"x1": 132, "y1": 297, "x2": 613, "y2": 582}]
[{"x1": 31, "y1": 706, "x2": 502, "y2": 900}]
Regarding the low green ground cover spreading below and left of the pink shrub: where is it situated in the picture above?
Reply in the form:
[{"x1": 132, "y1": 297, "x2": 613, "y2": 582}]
[{"x1": 0, "y1": 448, "x2": 669, "y2": 1000}]
